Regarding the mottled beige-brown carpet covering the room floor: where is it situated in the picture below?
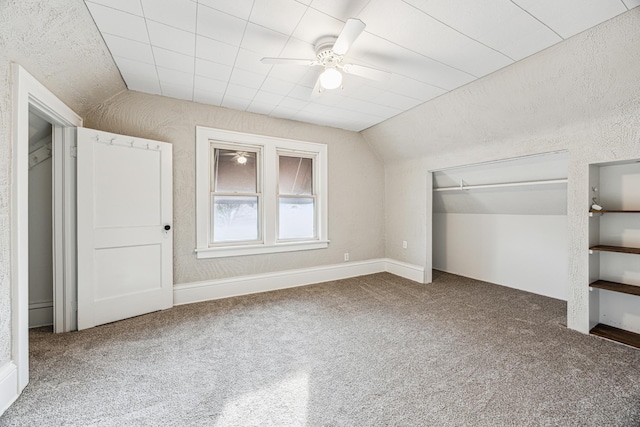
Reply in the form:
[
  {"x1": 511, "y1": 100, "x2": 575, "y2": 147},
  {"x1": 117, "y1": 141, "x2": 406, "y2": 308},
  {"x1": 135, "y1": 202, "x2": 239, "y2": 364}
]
[{"x1": 0, "y1": 273, "x2": 640, "y2": 426}]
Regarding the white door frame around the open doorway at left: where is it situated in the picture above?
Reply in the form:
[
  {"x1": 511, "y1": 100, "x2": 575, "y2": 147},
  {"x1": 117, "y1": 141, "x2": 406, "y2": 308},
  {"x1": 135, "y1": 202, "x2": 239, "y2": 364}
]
[{"x1": 11, "y1": 63, "x2": 82, "y2": 394}]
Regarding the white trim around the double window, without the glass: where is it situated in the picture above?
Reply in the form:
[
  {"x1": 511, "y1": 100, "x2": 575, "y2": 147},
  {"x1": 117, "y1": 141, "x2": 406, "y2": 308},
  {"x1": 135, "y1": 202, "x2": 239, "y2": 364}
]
[{"x1": 195, "y1": 126, "x2": 329, "y2": 259}]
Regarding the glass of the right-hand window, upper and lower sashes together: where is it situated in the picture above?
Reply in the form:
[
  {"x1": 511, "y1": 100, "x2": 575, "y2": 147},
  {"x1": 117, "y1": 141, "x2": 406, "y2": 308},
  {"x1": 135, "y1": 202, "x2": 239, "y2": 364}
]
[{"x1": 278, "y1": 155, "x2": 316, "y2": 240}]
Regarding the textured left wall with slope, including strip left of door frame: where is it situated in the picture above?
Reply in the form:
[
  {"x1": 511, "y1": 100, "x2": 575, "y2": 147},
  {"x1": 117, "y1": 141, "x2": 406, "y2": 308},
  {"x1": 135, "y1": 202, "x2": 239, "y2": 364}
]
[{"x1": 0, "y1": 0, "x2": 126, "y2": 366}]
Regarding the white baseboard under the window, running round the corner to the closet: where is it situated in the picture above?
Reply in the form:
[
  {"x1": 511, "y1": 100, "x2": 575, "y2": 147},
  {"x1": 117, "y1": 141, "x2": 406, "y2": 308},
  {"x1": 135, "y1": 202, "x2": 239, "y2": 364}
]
[{"x1": 173, "y1": 258, "x2": 424, "y2": 305}]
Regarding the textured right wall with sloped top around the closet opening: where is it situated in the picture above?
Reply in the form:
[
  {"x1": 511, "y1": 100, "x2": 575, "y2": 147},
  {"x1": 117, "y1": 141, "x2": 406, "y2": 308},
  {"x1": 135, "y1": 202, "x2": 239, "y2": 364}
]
[{"x1": 363, "y1": 8, "x2": 640, "y2": 332}]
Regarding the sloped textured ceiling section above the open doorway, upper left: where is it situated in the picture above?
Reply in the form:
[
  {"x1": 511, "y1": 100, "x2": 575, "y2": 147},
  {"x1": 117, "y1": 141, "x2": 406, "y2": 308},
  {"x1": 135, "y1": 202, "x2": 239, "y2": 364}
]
[{"x1": 0, "y1": 0, "x2": 127, "y2": 116}]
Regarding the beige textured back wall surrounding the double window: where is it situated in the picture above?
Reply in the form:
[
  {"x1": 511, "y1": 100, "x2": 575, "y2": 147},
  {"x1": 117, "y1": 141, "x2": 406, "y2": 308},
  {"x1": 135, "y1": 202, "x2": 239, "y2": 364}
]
[{"x1": 85, "y1": 91, "x2": 384, "y2": 284}]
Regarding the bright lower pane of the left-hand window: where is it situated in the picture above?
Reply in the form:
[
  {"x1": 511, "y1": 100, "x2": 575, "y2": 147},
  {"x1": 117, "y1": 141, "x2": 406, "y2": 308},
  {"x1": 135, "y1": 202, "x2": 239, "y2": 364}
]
[{"x1": 211, "y1": 196, "x2": 258, "y2": 243}]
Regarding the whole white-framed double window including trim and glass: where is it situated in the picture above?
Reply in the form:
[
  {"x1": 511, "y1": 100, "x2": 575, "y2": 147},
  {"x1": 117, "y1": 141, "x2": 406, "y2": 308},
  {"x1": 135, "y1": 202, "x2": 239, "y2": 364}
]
[{"x1": 196, "y1": 127, "x2": 329, "y2": 258}]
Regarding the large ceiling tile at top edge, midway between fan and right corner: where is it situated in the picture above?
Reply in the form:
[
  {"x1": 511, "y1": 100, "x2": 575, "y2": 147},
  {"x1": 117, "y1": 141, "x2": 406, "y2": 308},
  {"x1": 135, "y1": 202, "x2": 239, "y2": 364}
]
[{"x1": 404, "y1": 0, "x2": 562, "y2": 60}]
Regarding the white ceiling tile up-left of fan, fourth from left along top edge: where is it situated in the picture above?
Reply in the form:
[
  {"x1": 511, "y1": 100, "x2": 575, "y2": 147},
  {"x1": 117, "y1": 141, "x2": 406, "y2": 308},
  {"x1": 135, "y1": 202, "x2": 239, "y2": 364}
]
[{"x1": 249, "y1": 0, "x2": 307, "y2": 35}]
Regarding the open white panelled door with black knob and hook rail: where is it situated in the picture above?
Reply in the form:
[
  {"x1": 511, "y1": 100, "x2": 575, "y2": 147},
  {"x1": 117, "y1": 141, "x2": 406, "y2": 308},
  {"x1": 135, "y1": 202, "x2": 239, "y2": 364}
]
[{"x1": 77, "y1": 128, "x2": 173, "y2": 330}]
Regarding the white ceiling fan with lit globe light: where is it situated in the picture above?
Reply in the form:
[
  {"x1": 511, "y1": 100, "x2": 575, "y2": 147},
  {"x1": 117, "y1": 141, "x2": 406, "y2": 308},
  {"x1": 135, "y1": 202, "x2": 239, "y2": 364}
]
[{"x1": 262, "y1": 18, "x2": 391, "y2": 94}]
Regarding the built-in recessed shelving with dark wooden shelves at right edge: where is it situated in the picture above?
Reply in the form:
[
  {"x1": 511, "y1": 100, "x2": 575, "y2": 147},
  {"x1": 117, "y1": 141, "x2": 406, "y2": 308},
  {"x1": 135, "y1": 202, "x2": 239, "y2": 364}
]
[{"x1": 589, "y1": 160, "x2": 640, "y2": 348}]
